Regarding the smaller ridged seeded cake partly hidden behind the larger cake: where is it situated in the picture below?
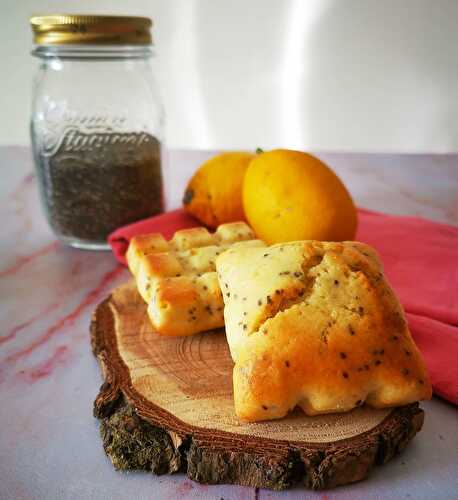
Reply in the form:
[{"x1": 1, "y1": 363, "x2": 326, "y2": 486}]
[{"x1": 126, "y1": 222, "x2": 265, "y2": 336}]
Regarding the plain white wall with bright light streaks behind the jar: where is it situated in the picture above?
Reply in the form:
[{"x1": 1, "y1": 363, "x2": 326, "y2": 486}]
[{"x1": 0, "y1": 0, "x2": 458, "y2": 152}]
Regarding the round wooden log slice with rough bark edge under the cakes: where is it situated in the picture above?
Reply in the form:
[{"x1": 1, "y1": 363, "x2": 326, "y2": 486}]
[{"x1": 91, "y1": 282, "x2": 423, "y2": 490}]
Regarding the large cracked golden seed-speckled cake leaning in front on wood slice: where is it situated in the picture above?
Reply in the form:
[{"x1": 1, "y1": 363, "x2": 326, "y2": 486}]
[{"x1": 217, "y1": 241, "x2": 431, "y2": 421}]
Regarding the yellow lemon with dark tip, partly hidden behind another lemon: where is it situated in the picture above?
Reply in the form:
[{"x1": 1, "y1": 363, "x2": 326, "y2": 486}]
[{"x1": 183, "y1": 152, "x2": 254, "y2": 228}]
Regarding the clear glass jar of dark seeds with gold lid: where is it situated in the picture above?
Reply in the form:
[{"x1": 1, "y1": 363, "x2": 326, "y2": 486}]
[{"x1": 30, "y1": 16, "x2": 164, "y2": 249}]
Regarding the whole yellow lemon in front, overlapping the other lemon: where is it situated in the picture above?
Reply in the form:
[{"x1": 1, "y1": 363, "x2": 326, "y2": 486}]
[{"x1": 243, "y1": 149, "x2": 357, "y2": 244}]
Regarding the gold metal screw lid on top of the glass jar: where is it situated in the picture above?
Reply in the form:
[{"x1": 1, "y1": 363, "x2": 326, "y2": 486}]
[{"x1": 30, "y1": 14, "x2": 153, "y2": 45}]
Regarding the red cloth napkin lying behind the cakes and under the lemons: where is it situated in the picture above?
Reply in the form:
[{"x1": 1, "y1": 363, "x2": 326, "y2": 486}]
[{"x1": 108, "y1": 209, "x2": 458, "y2": 404}]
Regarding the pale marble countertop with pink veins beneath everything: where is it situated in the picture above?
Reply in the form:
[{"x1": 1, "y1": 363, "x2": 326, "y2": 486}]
[{"x1": 0, "y1": 147, "x2": 458, "y2": 500}]
